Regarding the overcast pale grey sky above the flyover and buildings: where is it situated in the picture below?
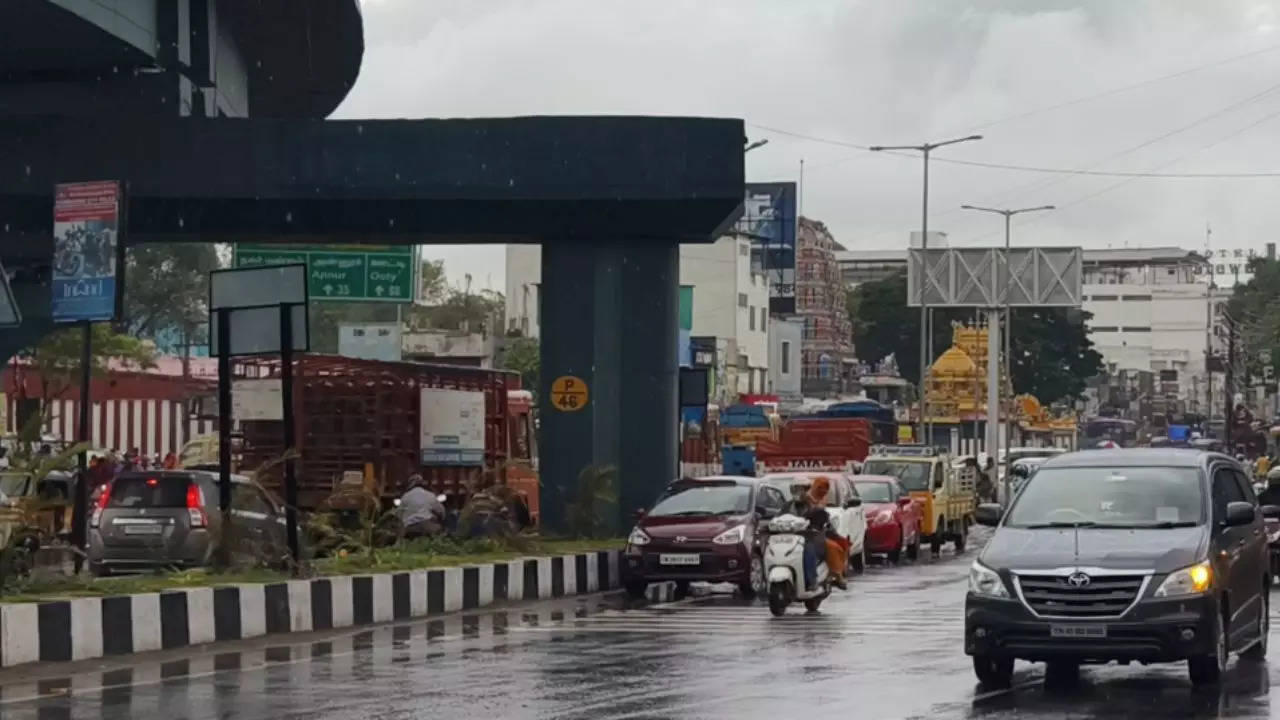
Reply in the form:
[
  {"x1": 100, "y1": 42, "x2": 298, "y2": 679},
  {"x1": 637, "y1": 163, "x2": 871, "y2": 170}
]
[{"x1": 334, "y1": 0, "x2": 1280, "y2": 290}]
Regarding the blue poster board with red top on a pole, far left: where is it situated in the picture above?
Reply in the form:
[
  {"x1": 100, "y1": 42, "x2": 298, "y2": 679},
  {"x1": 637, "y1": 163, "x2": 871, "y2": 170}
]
[{"x1": 51, "y1": 181, "x2": 120, "y2": 323}]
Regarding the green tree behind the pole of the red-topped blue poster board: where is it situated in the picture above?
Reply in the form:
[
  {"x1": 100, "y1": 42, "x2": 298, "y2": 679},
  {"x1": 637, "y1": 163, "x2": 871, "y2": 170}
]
[{"x1": 19, "y1": 323, "x2": 155, "y2": 421}]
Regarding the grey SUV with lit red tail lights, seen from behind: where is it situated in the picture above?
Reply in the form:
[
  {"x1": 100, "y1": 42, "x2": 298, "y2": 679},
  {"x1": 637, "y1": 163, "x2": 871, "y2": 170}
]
[{"x1": 88, "y1": 470, "x2": 287, "y2": 575}]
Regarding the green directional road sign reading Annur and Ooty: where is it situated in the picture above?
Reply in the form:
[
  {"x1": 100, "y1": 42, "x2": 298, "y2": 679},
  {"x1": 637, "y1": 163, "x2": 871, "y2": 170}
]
[{"x1": 234, "y1": 243, "x2": 416, "y2": 302}]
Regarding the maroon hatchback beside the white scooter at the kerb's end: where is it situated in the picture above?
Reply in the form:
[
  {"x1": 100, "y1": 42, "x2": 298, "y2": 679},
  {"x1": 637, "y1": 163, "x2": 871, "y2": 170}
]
[{"x1": 623, "y1": 477, "x2": 786, "y2": 597}]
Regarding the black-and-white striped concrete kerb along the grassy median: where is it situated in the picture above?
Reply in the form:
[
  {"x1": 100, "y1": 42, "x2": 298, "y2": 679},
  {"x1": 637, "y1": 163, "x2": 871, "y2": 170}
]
[{"x1": 0, "y1": 551, "x2": 621, "y2": 667}]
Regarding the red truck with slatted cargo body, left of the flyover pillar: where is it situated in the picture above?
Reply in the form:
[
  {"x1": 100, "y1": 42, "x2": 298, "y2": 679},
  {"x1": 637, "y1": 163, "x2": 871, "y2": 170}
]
[{"x1": 232, "y1": 354, "x2": 538, "y2": 518}]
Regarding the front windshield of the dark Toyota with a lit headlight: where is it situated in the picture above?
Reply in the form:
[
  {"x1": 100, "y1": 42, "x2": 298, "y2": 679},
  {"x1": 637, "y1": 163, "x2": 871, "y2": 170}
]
[{"x1": 1005, "y1": 468, "x2": 1204, "y2": 528}]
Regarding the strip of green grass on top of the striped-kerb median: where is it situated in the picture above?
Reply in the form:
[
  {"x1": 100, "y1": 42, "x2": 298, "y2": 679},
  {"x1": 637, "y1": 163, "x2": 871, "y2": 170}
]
[{"x1": 0, "y1": 538, "x2": 626, "y2": 602}]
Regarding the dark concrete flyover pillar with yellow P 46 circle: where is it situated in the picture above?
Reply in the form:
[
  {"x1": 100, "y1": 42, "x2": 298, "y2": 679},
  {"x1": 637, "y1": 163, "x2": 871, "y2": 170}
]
[{"x1": 539, "y1": 240, "x2": 680, "y2": 532}]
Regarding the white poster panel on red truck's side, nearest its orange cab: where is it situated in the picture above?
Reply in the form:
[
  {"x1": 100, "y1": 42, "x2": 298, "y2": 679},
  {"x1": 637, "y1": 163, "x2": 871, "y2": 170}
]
[{"x1": 419, "y1": 387, "x2": 484, "y2": 466}]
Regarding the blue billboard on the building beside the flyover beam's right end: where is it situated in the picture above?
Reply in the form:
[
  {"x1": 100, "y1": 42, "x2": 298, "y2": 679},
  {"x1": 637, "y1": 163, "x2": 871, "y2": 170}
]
[{"x1": 737, "y1": 182, "x2": 797, "y2": 315}]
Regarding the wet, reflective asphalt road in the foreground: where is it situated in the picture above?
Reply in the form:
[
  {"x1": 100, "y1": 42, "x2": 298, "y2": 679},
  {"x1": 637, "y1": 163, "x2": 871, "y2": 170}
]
[{"x1": 0, "y1": 530, "x2": 1280, "y2": 720}]
